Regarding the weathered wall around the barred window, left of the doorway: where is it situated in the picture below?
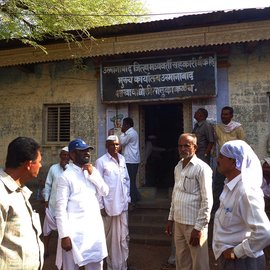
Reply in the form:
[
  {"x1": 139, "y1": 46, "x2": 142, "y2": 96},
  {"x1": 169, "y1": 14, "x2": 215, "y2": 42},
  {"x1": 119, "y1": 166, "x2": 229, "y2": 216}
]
[{"x1": 0, "y1": 61, "x2": 97, "y2": 180}]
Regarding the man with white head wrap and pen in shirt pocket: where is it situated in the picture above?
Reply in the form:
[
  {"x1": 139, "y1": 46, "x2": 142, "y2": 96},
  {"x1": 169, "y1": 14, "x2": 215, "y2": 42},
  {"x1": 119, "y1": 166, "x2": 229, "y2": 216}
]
[{"x1": 213, "y1": 140, "x2": 270, "y2": 270}]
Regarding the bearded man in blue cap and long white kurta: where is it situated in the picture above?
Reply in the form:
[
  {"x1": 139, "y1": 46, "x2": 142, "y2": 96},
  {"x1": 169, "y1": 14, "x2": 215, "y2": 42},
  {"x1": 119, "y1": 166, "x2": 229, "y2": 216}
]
[{"x1": 55, "y1": 138, "x2": 109, "y2": 270}]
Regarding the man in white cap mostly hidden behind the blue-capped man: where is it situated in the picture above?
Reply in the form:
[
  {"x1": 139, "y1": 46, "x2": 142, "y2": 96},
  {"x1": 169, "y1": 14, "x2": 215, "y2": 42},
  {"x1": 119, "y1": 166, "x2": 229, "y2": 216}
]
[{"x1": 43, "y1": 146, "x2": 69, "y2": 257}]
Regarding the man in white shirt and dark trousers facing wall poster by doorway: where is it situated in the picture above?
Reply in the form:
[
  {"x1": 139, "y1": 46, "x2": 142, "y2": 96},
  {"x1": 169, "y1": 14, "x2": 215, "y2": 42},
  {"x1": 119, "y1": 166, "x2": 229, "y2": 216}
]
[{"x1": 119, "y1": 117, "x2": 141, "y2": 208}]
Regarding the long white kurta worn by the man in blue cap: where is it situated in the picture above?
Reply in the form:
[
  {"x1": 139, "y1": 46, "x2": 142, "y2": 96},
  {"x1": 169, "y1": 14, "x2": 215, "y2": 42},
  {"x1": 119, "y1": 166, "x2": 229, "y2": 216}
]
[{"x1": 55, "y1": 164, "x2": 109, "y2": 269}]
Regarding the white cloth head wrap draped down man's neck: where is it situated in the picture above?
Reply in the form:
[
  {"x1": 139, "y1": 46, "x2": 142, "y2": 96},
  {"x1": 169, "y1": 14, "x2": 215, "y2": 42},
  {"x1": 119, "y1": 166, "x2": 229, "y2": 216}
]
[{"x1": 220, "y1": 140, "x2": 263, "y2": 187}]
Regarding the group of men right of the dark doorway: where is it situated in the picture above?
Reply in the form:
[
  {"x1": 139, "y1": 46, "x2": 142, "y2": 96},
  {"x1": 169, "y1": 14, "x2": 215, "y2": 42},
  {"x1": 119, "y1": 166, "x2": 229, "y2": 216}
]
[{"x1": 166, "y1": 106, "x2": 270, "y2": 270}]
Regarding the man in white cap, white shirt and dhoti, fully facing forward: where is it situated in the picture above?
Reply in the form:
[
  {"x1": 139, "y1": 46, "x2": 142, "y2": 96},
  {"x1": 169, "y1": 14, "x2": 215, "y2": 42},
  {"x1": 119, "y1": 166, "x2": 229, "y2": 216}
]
[{"x1": 96, "y1": 135, "x2": 130, "y2": 270}]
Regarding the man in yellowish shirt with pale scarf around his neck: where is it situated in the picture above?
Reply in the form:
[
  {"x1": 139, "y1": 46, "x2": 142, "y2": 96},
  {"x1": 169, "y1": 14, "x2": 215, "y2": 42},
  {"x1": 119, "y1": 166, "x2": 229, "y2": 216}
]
[{"x1": 212, "y1": 106, "x2": 245, "y2": 216}]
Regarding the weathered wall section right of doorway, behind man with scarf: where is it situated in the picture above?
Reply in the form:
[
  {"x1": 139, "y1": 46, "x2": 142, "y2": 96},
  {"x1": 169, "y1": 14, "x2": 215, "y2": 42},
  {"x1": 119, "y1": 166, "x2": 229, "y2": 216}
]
[{"x1": 228, "y1": 43, "x2": 270, "y2": 158}]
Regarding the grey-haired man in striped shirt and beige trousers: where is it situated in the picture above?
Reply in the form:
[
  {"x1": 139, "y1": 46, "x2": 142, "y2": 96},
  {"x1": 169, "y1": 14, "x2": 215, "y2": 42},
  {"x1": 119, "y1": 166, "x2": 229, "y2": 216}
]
[{"x1": 166, "y1": 133, "x2": 213, "y2": 270}]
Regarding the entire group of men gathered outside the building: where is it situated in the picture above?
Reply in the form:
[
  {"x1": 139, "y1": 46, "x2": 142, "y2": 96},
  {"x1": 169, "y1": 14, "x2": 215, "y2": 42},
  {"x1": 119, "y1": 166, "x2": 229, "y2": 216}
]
[{"x1": 0, "y1": 107, "x2": 270, "y2": 270}]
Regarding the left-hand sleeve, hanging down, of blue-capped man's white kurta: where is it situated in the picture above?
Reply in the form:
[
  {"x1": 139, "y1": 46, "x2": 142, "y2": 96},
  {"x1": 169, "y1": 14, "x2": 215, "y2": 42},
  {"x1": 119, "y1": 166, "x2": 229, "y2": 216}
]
[{"x1": 55, "y1": 176, "x2": 70, "y2": 239}]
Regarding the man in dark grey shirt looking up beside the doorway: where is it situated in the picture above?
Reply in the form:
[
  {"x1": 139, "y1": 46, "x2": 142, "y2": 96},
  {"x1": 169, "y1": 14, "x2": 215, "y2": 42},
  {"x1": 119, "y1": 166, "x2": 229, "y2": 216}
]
[{"x1": 192, "y1": 108, "x2": 214, "y2": 165}]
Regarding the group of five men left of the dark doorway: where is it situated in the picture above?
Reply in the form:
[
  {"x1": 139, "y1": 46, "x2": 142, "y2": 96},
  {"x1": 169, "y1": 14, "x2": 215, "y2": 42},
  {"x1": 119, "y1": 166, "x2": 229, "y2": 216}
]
[{"x1": 0, "y1": 117, "x2": 140, "y2": 270}]
